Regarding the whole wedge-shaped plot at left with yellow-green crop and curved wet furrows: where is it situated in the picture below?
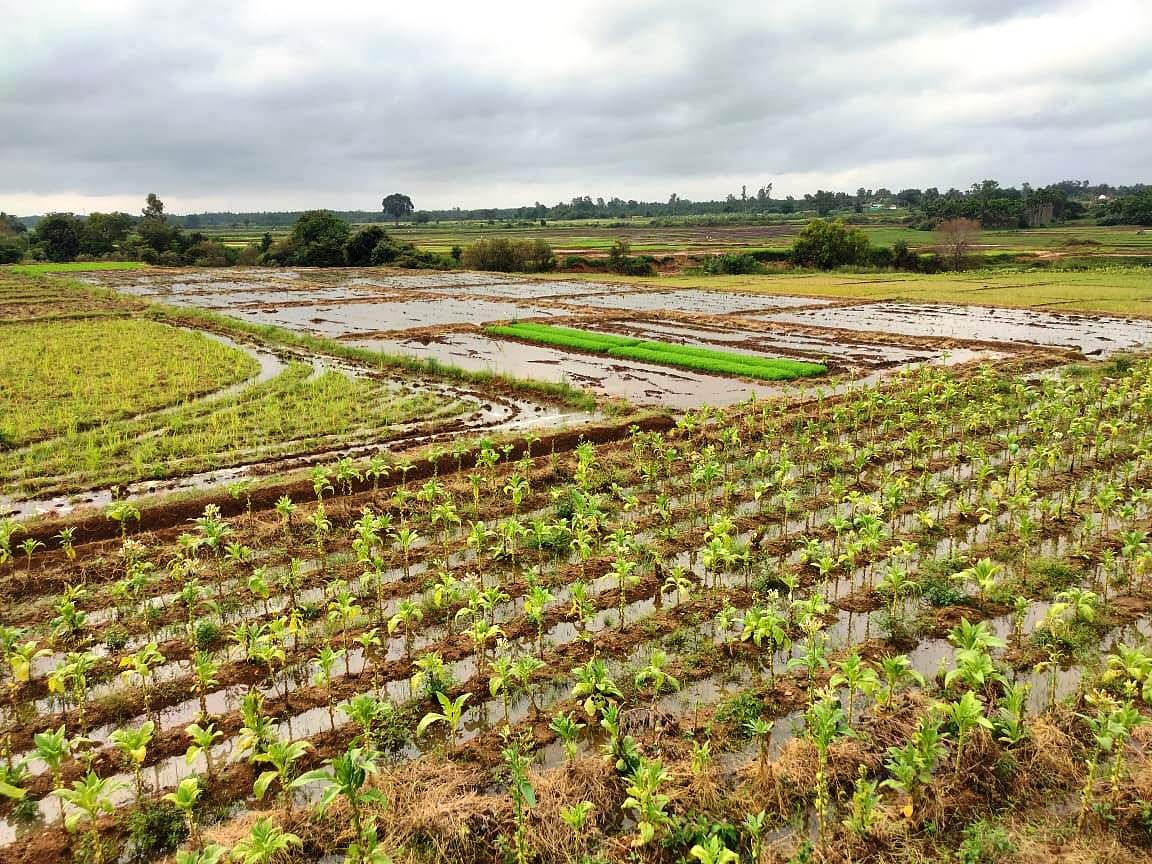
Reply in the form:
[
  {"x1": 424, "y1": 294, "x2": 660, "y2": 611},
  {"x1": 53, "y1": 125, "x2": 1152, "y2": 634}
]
[{"x1": 0, "y1": 274, "x2": 591, "y2": 516}]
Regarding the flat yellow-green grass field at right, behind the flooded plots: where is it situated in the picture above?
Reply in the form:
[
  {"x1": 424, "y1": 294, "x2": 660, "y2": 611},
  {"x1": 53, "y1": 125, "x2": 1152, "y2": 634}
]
[{"x1": 545, "y1": 267, "x2": 1152, "y2": 316}]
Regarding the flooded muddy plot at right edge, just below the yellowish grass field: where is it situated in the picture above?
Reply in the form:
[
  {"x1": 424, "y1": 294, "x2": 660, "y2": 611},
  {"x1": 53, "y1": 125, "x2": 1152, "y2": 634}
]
[{"x1": 765, "y1": 303, "x2": 1152, "y2": 356}]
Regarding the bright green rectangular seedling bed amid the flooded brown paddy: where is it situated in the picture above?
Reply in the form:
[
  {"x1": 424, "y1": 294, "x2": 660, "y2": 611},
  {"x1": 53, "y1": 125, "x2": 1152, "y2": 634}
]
[{"x1": 485, "y1": 323, "x2": 828, "y2": 381}]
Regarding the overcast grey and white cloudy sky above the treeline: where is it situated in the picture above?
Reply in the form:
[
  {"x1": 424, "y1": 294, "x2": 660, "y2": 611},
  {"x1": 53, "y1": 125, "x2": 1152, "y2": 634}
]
[{"x1": 0, "y1": 0, "x2": 1152, "y2": 214}]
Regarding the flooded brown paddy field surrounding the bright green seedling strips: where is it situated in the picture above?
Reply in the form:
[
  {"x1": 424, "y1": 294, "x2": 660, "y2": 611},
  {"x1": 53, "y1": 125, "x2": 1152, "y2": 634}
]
[{"x1": 85, "y1": 270, "x2": 1063, "y2": 410}]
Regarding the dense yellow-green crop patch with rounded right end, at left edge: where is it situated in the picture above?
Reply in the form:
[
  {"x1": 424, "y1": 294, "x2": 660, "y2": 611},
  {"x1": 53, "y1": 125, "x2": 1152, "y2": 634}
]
[{"x1": 0, "y1": 318, "x2": 259, "y2": 447}]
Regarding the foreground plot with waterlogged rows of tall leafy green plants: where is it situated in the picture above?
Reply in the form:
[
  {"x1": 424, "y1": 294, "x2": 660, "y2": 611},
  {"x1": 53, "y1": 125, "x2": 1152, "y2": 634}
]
[{"x1": 0, "y1": 361, "x2": 1152, "y2": 862}]
